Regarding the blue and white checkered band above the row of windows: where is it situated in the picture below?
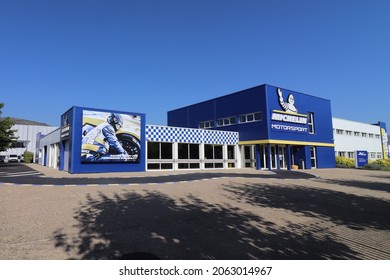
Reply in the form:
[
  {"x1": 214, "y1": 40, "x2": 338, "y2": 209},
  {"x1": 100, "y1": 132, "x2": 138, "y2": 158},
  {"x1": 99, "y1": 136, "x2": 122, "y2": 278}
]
[{"x1": 146, "y1": 125, "x2": 238, "y2": 145}]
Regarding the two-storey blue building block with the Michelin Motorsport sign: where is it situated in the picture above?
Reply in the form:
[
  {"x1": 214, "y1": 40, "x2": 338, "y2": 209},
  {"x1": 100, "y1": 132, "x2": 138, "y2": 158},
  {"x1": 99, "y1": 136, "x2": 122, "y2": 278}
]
[{"x1": 168, "y1": 84, "x2": 335, "y2": 169}]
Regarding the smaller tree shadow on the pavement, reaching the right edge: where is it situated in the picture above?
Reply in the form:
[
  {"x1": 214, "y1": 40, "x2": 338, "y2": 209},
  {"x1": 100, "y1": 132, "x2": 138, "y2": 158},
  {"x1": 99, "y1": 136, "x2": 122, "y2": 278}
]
[{"x1": 225, "y1": 181, "x2": 390, "y2": 230}]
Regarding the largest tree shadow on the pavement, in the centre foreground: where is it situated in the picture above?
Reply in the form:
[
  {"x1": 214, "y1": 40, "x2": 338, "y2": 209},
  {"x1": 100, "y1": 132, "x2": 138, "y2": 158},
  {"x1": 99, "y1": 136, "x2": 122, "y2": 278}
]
[{"x1": 53, "y1": 189, "x2": 362, "y2": 260}]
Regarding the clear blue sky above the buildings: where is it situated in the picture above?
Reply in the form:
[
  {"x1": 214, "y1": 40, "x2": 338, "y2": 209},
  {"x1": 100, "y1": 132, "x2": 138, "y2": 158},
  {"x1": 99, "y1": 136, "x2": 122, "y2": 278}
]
[{"x1": 0, "y1": 0, "x2": 390, "y2": 130}]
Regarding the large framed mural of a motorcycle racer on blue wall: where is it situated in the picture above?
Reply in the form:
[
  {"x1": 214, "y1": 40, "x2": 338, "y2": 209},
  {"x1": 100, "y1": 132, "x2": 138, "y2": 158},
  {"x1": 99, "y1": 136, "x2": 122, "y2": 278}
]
[{"x1": 81, "y1": 111, "x2": 140, "y2": 163}]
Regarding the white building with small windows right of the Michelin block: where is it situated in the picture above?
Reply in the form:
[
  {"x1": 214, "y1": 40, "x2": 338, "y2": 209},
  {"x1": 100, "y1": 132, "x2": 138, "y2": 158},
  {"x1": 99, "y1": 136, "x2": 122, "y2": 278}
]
[{"x1": 332, "y1": 118, "x2": 387, "y2": 160}]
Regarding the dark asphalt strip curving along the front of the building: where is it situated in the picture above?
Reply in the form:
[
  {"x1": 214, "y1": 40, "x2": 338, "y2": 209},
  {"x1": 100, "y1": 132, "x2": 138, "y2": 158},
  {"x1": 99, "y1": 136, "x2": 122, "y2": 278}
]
[{"x1": 0, "y1": 163, "x2": 316, "y2": 186}]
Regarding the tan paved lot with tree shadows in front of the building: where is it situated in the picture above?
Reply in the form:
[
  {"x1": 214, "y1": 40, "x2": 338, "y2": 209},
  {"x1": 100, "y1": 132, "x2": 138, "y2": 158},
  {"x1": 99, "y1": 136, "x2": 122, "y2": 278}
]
[{"x1": 0, "y1": 165, "x2": 390, "y2": 260}]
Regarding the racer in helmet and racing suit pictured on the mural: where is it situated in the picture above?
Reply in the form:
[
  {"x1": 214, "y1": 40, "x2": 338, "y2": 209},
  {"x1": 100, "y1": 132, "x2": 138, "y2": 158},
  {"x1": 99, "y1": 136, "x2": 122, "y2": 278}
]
[{"x1": 81, "y1": 113, "x2": 128, "y2": 162}]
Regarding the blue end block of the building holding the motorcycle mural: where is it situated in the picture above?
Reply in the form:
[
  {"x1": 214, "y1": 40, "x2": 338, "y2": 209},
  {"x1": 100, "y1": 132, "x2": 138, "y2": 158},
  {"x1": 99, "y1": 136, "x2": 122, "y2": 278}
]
[{"x1": 59, "y1": 107, "x2": 146, "y2": 173}]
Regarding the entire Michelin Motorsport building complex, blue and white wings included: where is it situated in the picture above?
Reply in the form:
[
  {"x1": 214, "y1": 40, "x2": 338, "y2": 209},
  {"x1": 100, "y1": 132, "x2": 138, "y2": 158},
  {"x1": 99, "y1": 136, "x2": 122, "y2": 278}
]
[{"x1": 12, "y1": 84, "x2": 388, "y2": 173}]
